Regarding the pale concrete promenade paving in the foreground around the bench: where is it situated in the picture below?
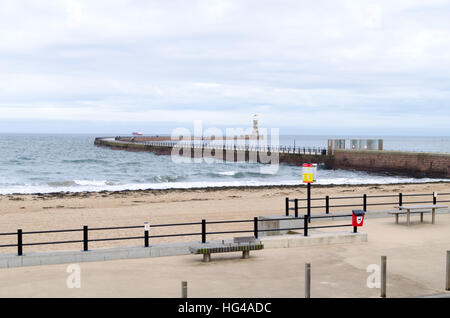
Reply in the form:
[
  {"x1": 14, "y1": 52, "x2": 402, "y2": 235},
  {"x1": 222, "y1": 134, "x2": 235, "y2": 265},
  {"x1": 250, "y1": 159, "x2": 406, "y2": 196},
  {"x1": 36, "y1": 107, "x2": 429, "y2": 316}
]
[{"x1": 0, "y1": 214, "x2": 450, "y2": 297}]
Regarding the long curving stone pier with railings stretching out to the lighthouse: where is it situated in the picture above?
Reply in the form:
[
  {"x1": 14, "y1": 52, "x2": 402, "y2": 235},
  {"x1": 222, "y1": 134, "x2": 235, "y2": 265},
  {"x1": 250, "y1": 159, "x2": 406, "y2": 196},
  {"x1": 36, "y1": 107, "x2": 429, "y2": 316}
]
[{"x1": 94, "y1": 136, "x2": 450, "y2": 179}]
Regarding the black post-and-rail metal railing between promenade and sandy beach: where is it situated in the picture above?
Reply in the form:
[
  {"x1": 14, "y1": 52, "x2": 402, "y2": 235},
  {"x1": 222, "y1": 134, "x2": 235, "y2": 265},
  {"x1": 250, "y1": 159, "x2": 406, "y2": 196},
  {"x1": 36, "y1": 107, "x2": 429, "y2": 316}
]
[{"x1": 0, "y1": 193, "x2": 450, "y2": 256}]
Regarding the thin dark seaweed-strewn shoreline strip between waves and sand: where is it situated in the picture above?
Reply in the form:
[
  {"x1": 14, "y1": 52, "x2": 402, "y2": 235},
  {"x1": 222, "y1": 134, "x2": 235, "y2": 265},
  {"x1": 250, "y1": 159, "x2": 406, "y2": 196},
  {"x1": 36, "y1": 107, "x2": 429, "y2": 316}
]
[{"x1": 0, "y1": 179, "x2": 450, "y2": 198}]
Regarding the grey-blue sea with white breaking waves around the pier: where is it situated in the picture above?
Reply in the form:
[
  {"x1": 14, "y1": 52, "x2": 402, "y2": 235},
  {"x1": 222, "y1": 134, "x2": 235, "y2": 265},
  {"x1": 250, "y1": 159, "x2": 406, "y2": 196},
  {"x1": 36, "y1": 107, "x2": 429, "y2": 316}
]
[{"x1": 0, "y1": 134, "x2": 450, "y2": 194}]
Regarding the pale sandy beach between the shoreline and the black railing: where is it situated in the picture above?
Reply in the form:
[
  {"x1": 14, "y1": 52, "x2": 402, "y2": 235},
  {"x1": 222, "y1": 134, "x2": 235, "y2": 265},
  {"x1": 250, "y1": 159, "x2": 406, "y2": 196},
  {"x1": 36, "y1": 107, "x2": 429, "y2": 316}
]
[{"x1": 0, "y1": 182, "x2": 450, "y2": 253}]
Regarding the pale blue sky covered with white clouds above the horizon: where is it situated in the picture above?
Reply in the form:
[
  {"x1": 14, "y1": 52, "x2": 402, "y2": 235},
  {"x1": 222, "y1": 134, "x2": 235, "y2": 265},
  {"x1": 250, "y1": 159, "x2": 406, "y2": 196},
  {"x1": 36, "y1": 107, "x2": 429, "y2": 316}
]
[{"x1": 0, "y1": 0, "x2": 450, "y2": 136}]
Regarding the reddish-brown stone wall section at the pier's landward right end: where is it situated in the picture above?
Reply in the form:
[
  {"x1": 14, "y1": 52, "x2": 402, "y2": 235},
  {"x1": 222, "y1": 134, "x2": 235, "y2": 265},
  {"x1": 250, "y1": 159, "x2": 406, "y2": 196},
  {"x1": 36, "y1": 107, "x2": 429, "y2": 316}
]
[{"x1": 333, "y1": 150, "x2": 450, "y2": 178}]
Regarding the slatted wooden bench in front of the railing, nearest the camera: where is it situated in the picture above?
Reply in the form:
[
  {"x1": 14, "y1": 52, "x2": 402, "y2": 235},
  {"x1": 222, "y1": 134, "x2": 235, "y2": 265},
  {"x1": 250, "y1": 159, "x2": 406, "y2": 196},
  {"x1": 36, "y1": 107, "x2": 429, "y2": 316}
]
[{"x1": 189, "y1": 236, "x2": 264, "y2": 262}]
